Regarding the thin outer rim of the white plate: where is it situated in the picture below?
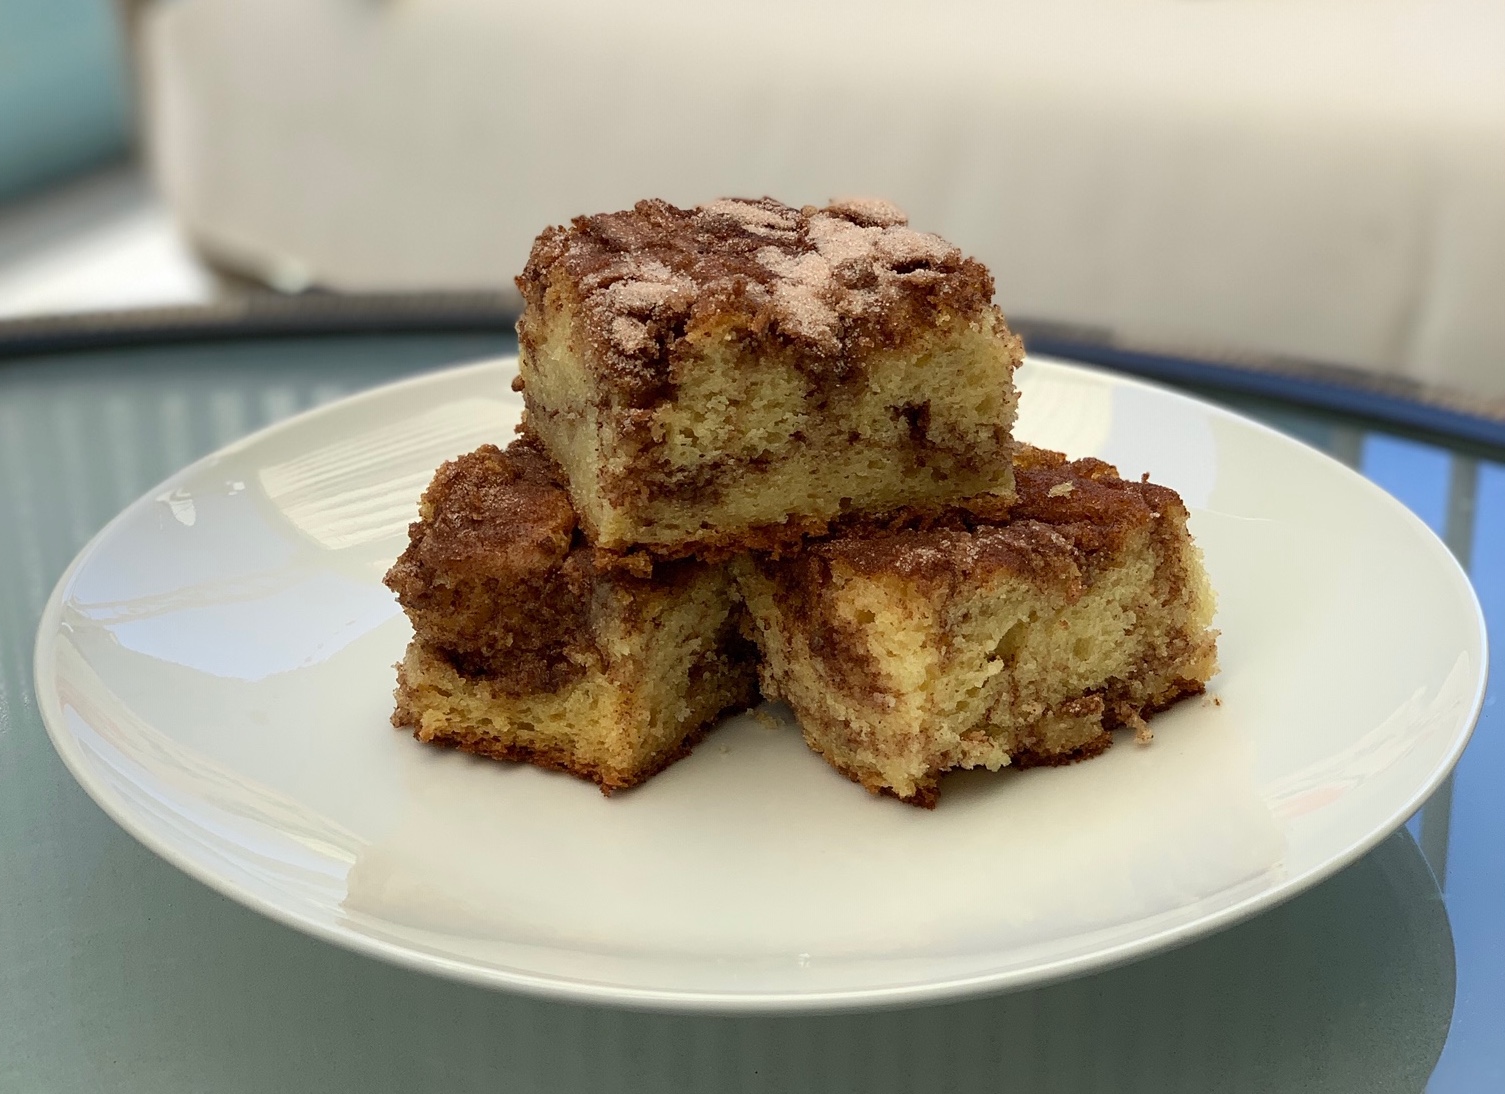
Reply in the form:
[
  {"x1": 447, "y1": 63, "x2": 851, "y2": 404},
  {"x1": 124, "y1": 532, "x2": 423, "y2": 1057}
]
[{"x1": 32, "y1": 354, "x2": 1490, "y2": 1014}]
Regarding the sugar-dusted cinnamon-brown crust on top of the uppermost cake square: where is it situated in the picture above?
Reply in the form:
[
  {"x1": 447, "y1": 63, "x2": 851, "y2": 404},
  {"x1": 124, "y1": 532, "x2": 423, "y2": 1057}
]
[{"x1": 518, "y1": 197, "x2": 993, "y2": 408}]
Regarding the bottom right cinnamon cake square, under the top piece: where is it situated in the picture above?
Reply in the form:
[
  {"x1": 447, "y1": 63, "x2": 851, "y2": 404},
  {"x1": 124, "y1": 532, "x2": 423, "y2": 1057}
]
[{"x1": 737, "y1": 448, "x2": 1218, "y2": 807}]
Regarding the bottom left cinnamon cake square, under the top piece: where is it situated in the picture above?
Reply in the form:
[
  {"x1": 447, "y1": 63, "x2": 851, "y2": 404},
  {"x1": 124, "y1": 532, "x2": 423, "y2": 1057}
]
[{"x1": 387, "y1": 441, "x2": 757, "y2": 793}]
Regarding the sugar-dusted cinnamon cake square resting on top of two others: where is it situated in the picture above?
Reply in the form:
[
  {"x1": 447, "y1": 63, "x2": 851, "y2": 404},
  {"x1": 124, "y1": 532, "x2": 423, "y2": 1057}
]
[{"x1": 518, "y1": 199, "x2": 1022, "y2": 557}]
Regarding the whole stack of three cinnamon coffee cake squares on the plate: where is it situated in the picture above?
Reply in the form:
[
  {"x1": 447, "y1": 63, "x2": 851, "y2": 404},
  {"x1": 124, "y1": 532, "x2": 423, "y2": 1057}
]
[{"x1": 387, "y1": 199, "x2": 1216, "y2": 807}]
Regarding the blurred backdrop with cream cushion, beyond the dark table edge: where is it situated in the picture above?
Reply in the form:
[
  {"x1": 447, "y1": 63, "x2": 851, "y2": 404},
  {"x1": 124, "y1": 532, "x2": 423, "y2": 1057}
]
[{"x1": 0, "y1": 0, "x2": 1505, "y2": 406}]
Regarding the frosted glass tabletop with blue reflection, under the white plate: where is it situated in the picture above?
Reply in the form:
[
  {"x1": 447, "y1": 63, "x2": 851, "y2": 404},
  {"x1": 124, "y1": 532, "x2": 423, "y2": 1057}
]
[{"x1": 0, "y1": 330, "x2": 1505, "y2": 1094}]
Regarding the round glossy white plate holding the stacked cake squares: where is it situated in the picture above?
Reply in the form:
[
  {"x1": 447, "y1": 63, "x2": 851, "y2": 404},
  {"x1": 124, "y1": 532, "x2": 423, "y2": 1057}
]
[{"x1": 36, "y1": 360, "x2": 1487, "y2": 1011}]
